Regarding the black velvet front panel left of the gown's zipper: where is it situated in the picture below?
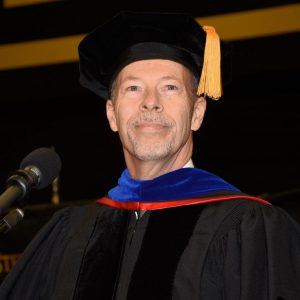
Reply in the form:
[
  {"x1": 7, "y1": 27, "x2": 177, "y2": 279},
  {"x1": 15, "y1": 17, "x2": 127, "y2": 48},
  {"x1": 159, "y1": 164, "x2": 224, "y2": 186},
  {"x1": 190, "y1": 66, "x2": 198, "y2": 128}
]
[{"x1": 74, "y1": 206, "x2": 129, "y2": 300}]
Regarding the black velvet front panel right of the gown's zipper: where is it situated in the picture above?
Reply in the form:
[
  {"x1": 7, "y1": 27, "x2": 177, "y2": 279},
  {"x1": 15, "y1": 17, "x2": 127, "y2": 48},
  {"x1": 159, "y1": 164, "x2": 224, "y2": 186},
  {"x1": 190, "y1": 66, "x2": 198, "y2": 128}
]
[{"x1": 128, "y1": 205, "x2": 205, "y2": 300}]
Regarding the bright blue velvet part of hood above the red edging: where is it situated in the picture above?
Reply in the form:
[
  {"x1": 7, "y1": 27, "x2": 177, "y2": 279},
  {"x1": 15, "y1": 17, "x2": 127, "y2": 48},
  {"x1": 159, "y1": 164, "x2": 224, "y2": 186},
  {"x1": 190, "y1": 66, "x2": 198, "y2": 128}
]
[{"x1": 108, "y1": 168, "x2": 240, "y2": 202}]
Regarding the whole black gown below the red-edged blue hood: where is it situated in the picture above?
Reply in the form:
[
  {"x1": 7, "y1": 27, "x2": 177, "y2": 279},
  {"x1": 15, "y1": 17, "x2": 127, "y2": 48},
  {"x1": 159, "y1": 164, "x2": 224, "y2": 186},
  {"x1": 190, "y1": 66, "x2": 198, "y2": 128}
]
[{"x1": 0, "y1": 193, "x2": 300, "y2": 300}]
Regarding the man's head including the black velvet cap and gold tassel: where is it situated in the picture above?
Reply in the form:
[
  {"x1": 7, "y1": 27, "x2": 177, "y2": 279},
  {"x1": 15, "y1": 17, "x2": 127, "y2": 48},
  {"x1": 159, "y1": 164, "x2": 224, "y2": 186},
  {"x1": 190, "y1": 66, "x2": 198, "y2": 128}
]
[{"x1": 79, "y1": 12, "x2": 231, "y2": 176}]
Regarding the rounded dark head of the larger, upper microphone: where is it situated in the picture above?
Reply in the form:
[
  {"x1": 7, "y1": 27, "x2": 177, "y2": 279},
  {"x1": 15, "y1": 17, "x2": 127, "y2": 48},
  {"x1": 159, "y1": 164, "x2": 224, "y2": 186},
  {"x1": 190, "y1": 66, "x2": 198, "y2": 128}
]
[{"x1": 20, "y1": 148, "x2": 61, "y2": 189}]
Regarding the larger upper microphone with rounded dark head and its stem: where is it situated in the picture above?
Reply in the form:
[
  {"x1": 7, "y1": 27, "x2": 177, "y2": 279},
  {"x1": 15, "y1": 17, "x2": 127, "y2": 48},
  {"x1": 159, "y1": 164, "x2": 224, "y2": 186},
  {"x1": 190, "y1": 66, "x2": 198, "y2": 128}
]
[{"x1": 0, "y1": 148, "x2": 61, "y2": 214}]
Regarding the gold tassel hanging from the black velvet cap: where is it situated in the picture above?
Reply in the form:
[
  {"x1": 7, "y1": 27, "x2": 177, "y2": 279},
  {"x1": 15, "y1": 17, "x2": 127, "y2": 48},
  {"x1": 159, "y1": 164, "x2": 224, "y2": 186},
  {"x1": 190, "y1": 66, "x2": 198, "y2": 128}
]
[{"x1": 197, "y1": 26, "x2": 222, "y2": 100}]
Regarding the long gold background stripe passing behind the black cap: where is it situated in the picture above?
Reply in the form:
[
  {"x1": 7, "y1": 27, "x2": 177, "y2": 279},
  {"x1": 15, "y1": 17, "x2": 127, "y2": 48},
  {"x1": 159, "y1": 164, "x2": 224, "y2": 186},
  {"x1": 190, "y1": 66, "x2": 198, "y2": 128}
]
[{"x1": 0, "y1": 4, "x2": 300, "y2": 70}]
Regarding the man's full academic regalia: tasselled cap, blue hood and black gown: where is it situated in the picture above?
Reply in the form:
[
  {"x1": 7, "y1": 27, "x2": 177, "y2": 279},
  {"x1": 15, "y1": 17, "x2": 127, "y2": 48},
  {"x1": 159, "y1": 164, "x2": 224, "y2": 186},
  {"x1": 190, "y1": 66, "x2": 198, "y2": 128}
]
[{"x1": 0, "y1": 12, "x2": 300, "y2": 300}]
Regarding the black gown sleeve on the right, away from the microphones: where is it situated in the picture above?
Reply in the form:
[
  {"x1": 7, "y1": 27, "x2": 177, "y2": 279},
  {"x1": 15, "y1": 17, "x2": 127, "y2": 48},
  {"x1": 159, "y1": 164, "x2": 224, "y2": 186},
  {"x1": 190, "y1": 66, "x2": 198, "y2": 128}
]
[{"x1": 201, "y1": 204, "x2": 300, "y2": 300}]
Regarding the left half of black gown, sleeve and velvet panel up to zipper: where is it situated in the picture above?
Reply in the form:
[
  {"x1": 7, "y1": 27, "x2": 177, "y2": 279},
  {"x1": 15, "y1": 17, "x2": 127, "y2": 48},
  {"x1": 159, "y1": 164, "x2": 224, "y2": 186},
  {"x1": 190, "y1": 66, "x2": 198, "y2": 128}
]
[{"x1": 0, "y1": 203, "x2": 127, "y2": 300}]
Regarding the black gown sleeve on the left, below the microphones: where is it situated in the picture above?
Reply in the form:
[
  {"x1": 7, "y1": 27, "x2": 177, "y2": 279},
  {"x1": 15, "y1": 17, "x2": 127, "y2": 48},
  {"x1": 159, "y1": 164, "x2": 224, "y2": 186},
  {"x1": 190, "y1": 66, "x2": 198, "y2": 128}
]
[{"x1": 0, "y1": 204, "x2": 97, "y2": 300}]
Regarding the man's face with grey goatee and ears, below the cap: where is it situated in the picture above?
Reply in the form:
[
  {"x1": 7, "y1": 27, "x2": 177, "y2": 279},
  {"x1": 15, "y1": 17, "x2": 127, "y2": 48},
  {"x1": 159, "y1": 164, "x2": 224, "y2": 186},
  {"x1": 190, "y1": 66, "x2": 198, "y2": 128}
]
[{"x1": 107, "y1": 59, "x2": 205, "y2": 161}]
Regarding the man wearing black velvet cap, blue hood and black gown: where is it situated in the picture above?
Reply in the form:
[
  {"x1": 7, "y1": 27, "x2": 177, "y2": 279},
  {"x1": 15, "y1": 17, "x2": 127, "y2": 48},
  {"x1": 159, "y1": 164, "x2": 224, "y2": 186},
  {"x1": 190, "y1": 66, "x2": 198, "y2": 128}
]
[{"x1": 0, "y1": 12, "x2": 300, "y2": 300}]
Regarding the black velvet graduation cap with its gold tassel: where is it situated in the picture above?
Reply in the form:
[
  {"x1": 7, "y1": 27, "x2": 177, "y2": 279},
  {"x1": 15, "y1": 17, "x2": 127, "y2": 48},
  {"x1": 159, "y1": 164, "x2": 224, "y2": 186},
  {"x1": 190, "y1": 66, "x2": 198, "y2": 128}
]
[{"x1": 78, "y1": 11, "x2": 231, "y2": 100}]
